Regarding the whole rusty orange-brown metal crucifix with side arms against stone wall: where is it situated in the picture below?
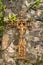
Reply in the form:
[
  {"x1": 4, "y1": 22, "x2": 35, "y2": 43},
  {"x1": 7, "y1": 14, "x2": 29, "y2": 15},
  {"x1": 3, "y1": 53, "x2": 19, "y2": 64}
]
[{"x1": 7, "y1": 12, "x2": 34, "y2": 59}]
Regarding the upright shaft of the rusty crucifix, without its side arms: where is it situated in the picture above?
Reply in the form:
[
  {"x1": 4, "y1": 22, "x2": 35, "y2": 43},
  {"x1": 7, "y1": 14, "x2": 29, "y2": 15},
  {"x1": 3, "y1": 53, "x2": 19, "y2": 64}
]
[{"x1": 16, "y1": 11, "x2": 27, "y2": 59}]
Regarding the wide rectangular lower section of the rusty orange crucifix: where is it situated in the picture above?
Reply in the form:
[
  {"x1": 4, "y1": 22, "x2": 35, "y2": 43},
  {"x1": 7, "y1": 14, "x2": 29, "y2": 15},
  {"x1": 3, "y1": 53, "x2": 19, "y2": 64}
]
[{"x1": 18, "y1": 39, "x2": 26, "y2": 59}]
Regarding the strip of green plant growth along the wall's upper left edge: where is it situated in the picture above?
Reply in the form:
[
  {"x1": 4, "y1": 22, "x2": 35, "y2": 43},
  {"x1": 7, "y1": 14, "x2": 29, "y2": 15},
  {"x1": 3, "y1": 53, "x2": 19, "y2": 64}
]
[{"x1": 0, "y1": 0, "x2": 6, "y2": 38}]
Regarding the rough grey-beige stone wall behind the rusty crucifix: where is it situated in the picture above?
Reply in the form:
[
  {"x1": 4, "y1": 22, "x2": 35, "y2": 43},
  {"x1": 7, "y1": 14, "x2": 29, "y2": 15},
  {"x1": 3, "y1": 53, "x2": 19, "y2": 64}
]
[{"x1": 0, "y1": 0, "x2": 43, "y2": 65}]
